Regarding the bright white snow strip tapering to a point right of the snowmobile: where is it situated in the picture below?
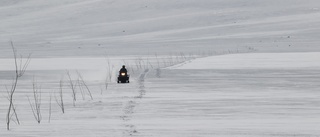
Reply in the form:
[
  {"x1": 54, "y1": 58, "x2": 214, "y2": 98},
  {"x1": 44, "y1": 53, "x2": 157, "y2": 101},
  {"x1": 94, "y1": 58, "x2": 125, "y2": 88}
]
[{"x1": 170, "y1": 52, "x2": 320, "y2": 69}]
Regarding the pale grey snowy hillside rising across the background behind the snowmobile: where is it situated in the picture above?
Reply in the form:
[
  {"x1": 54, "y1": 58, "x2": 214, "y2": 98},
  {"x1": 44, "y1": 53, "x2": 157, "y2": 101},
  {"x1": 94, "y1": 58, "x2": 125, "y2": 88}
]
[{"x1": 0, "y1": 0, "x2": 320, "y2": 57}]
